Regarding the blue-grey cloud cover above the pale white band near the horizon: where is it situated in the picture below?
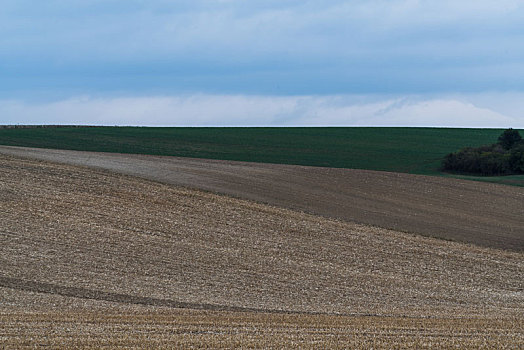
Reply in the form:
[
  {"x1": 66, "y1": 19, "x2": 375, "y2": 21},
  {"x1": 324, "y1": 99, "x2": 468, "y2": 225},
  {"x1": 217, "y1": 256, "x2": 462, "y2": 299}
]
[{"x1": 0, "y1": 0, "x2": 524, "y2": 95}]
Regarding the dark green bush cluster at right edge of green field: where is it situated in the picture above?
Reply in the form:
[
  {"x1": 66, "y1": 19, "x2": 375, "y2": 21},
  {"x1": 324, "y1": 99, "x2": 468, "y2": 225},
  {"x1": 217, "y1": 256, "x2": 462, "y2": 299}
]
[{"x1": 442, "y1": 129, "x2": 524, "y2": 175}]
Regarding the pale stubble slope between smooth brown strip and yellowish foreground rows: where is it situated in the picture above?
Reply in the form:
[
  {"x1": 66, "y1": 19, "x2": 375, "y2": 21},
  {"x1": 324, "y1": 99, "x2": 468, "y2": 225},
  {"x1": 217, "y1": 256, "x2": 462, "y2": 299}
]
[{"x1": 0, "y1": 153, "x2": 524, "y2": 315}]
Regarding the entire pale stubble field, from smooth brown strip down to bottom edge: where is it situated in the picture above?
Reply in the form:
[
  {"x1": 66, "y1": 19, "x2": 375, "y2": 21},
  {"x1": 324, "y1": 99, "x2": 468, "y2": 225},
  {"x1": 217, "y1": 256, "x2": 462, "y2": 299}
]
[{"x1": 0, "y1": 155, "x2": 524, "y2": 348}]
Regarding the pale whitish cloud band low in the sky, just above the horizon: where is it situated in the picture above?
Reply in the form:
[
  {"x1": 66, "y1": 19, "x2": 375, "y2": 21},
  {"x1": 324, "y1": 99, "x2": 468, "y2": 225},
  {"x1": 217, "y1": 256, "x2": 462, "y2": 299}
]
[{"x1": 0, "y1": 94, "x2": 524, "y2": 128}]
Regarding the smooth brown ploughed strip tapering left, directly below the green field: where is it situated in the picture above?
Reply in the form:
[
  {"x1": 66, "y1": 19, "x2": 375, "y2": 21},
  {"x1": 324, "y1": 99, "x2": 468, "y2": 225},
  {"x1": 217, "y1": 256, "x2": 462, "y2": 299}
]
[{"x1": 0, "y1": 146, "x2": 524, "y2": 251}]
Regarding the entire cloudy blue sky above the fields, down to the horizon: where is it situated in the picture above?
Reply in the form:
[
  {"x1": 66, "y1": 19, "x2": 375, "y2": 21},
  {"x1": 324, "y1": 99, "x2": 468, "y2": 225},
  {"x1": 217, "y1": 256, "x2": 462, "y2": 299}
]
[{"x1": 0, "y1": 0, "x2": 524, "y2": 128}]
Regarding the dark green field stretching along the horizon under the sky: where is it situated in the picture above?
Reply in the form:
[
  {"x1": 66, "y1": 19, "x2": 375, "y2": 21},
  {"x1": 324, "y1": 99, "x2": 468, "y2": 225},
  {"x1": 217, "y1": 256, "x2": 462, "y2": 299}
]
[{"x1": 0, "y1": 127, "x2": 524, "y2": 186}]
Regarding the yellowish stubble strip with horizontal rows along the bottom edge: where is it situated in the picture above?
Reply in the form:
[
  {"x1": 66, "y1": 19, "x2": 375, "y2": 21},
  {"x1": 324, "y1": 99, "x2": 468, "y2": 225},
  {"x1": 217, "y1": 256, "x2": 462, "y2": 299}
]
[{"x1": 0, "y1": 310, "x2": 523, "y2": 349}]
